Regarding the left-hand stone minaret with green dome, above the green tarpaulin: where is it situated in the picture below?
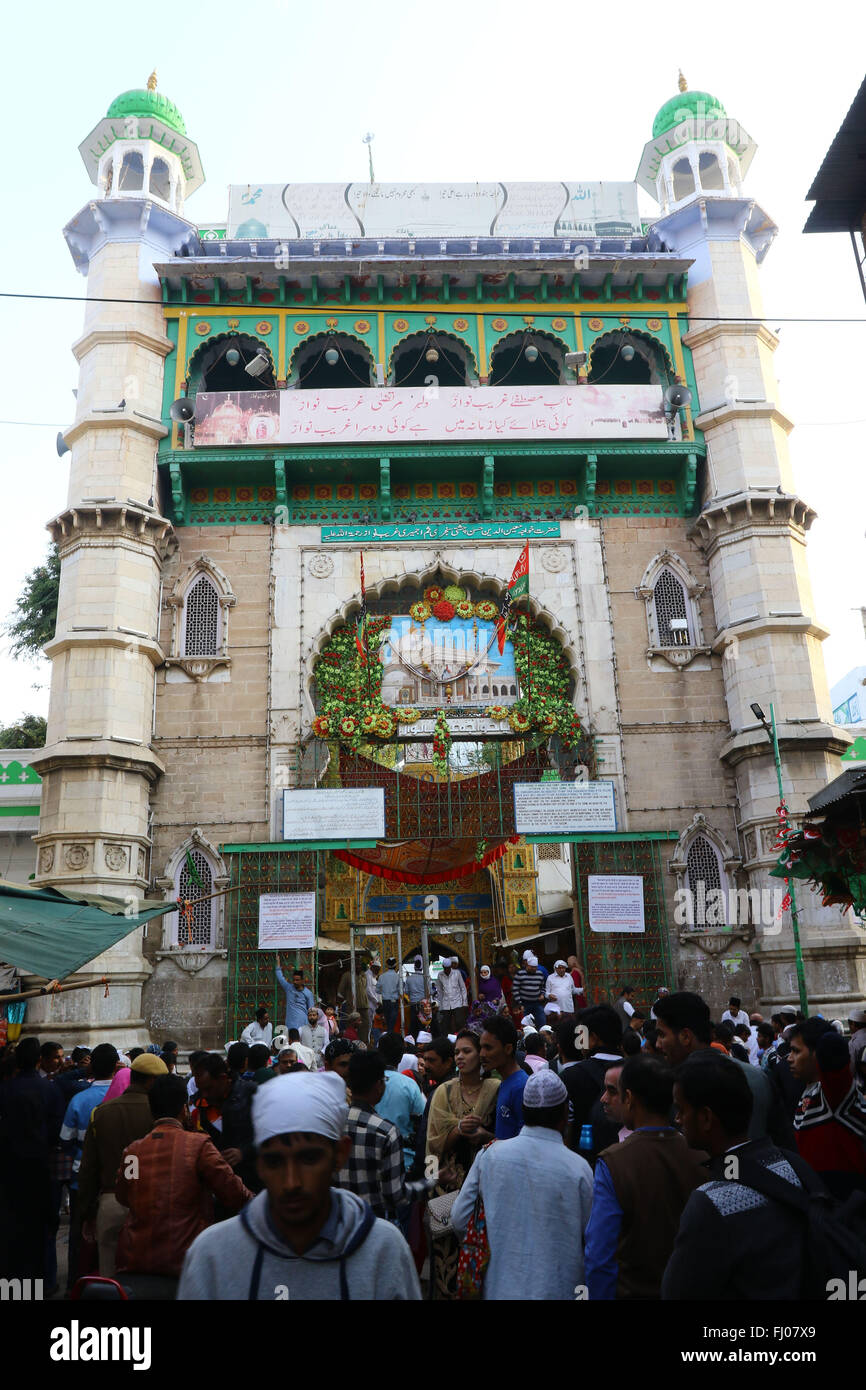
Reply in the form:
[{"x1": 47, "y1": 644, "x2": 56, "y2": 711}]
[{"x1": 26, "y1": 74, "x2": 203, "y2": 1045}]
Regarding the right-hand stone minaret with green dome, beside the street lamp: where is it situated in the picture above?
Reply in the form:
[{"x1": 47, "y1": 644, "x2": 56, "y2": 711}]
[{"x1": 638, "y1": 74, "x2": 866, "y2": 1013}]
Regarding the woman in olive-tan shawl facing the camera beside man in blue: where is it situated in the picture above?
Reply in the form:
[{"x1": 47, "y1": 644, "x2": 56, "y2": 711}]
[{"x1": 427, "y1": 1029, "x2": 499, "y2": 1300}]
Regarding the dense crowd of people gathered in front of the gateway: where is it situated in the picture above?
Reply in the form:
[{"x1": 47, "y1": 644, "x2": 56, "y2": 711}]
[{"x1": 0, "y1": 952, "x2": 866, "y2": 1301}]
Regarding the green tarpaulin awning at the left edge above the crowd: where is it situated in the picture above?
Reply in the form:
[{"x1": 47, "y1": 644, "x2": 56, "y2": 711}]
[{"x1": 0, "y1": 878, "x2": 178, "y2": 980}]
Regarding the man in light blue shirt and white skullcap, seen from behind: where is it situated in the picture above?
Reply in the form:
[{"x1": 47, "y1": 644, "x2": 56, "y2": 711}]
[{"x1": 450, "y1": 1068, "x2": 592, "y2": 1301}]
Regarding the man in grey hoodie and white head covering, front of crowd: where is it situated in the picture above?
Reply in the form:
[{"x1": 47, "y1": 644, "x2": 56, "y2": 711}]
[{"x1": 178, "y1": 1072, "x2": 421, "y2": 1301}]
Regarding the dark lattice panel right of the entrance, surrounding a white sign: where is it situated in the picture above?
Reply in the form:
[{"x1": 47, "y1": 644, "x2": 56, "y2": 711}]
[{"x1": 574, "y1": 840, "x2": 673, "y2": 1012}]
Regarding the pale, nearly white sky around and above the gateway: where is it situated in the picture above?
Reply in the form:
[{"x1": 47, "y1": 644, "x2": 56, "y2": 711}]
[{"x1": 0, "y1": 0, "x2": 866, "y2": 723}]
